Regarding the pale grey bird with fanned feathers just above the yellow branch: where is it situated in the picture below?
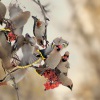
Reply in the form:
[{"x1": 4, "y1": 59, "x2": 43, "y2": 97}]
[{"x1": 20, "y1": 34, "x2": 42, "y2": 65}]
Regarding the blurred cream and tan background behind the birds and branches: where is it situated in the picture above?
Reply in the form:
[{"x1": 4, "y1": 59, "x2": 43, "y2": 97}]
[{"x1": 0, "y1": 0, "x2": 100, "y2": 100}]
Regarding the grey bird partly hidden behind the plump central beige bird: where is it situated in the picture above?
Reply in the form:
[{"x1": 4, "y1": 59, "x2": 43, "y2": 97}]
[{"x1": 40, "y1": 37, "x2": 69, "y2": 58}]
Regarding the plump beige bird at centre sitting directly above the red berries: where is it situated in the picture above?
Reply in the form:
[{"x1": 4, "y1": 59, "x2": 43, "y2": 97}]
[{"x1": 41, "y1": 45, "x2": 67, "y2": 75}]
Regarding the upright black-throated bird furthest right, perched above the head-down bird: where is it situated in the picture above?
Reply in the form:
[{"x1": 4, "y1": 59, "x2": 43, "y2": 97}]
[{"x1": 56, "y1": 51, "x2": 70, "y2": 76}]
